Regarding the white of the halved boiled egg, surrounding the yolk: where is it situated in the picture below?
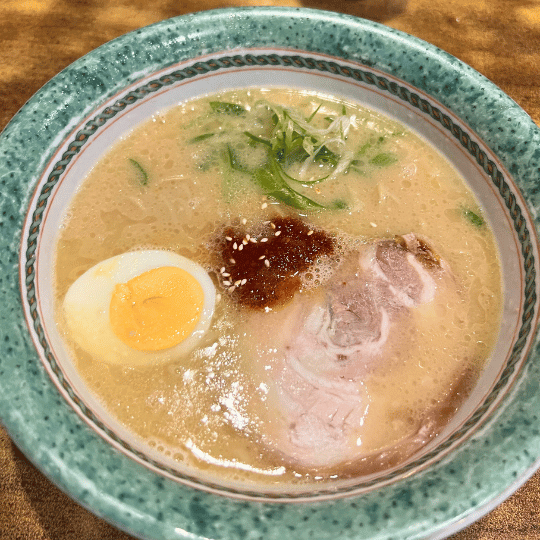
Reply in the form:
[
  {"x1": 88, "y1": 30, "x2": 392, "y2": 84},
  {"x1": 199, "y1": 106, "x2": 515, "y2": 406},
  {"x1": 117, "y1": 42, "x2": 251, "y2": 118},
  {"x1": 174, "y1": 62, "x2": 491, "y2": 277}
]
[{"x1": 63, "y1": 250, "x2": 216, "y2": 366}]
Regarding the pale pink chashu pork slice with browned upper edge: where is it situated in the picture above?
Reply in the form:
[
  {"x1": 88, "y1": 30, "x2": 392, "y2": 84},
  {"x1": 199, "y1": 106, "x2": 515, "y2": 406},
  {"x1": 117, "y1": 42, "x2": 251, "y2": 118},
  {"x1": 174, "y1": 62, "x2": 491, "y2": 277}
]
[{"x1": 240, "y1": 234, "x2": 448, "y2": 468}]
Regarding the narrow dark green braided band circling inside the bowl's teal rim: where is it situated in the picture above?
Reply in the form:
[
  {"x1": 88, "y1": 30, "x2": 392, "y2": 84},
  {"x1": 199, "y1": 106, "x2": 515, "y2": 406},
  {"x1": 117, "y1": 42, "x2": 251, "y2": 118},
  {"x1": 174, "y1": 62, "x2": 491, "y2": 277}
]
[{"x1": 20, "y1": 53, "x2": 536, "y2": 498}]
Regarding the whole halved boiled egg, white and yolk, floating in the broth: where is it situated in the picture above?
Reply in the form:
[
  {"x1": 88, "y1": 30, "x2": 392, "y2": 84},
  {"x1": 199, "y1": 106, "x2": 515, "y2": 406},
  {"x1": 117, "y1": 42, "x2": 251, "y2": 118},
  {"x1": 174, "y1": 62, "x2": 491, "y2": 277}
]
[{"x1": 63, "y1": 250, "x2": 216, "y2": 365}]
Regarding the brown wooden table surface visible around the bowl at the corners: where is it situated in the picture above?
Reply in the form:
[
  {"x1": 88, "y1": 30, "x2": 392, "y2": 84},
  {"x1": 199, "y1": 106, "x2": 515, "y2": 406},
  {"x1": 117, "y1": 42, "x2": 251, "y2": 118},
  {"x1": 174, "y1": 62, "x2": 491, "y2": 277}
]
[{"x1": 0, "y1": 0, "x2": 540, "y2": 540}]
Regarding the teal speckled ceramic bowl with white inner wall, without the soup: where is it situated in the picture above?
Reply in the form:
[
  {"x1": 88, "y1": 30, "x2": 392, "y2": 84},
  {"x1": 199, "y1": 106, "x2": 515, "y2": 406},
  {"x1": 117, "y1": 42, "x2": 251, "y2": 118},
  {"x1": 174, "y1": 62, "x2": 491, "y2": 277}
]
[{"x1": 0, "y1": 8, "x2": 540, "y2": 540}]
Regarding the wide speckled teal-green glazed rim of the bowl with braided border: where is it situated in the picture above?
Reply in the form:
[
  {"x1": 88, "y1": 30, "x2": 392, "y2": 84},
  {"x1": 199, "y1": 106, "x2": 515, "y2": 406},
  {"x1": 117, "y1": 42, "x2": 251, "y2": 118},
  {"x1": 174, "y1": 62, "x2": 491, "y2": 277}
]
[{"x1": 0, "y1": 8, "x2": 540, "y2": 540}]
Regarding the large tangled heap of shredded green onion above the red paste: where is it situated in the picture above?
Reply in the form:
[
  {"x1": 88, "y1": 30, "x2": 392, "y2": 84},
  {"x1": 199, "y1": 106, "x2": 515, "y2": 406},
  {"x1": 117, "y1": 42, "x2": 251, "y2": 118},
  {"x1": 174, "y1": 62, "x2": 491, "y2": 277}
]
[{"x1": 194, "y1": 100, "x2": 397, "y2": 210}]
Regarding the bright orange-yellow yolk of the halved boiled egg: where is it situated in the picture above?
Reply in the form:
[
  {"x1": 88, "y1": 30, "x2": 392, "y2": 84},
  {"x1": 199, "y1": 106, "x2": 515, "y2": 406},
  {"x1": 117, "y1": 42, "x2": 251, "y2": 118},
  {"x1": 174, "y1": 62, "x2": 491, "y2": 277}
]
[{"x1": 109, "y1": 266, "x2": 204, "y2": 351}]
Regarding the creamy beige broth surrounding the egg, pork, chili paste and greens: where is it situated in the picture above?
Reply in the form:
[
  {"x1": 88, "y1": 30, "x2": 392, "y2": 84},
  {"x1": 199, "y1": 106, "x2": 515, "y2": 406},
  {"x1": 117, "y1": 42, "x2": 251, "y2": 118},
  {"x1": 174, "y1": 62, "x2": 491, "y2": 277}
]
[{"x1": 56, "y1": 89, "x2": 502, "y2": 483}]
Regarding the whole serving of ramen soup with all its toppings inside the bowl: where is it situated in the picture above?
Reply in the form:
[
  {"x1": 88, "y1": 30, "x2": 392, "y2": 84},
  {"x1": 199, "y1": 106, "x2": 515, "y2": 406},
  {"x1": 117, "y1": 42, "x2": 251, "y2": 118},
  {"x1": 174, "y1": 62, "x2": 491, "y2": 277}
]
[{"x1": 56, "y1": 89, "x2": 502, "y2": 485}]
